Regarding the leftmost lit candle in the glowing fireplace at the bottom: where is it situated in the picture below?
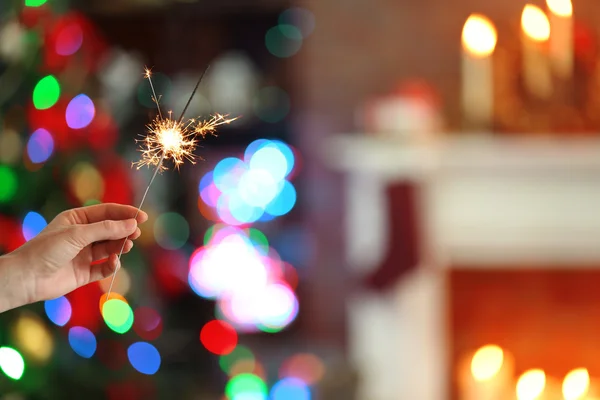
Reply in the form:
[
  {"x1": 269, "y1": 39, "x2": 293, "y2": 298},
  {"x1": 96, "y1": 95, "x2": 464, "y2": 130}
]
[{"x1": 459, "y1": 345, "x2": 514, "y2": 400}]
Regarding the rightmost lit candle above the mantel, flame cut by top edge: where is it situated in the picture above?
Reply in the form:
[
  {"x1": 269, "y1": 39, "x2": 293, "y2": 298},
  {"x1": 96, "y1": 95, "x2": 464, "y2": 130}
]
[{"x1": 546, "y1": 0, "x2": 574, "y2": 79}]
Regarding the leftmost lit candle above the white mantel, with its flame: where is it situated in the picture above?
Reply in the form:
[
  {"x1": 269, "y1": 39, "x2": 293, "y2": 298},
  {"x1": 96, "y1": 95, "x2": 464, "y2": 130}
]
[{"x1": 462, "y1": 14, "x2": 498, "y2": 129}]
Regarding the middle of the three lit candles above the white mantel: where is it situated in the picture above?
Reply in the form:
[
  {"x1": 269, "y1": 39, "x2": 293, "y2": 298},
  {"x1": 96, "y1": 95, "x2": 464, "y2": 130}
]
[{"x1": 521, "y1": 4, "x2": 552, "y2": 99}]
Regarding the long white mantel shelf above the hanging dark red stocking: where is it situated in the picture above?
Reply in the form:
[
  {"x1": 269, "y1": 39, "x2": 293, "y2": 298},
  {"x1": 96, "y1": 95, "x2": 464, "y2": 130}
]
[{"x1": 324, "y1": 134, "x2": 600, "y2": 177}]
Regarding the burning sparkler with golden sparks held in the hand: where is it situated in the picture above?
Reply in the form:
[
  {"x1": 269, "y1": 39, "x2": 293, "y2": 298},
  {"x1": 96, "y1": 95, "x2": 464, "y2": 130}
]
[{"x1": 106, "y1": 68, "x2": 237, "y2": 301}]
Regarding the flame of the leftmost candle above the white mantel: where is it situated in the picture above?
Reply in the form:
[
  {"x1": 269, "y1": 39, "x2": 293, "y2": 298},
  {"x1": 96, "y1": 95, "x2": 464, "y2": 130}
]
[{"x1": 462, "y1": 14, "x2": 498, "y2": 57}]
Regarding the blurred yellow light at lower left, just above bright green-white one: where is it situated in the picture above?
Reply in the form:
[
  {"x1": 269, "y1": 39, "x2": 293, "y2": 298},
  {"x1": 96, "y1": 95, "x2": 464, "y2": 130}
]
[{"x1": 13, "y1": 313, "x2": 54, "y2": 363}]
